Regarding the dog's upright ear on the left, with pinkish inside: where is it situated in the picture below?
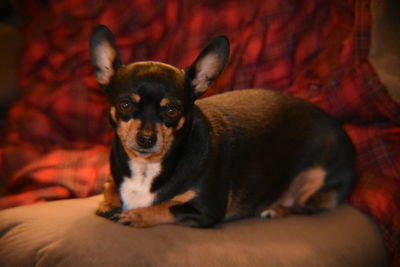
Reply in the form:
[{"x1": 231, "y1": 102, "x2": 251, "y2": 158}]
[{"x1": 90, "y1": 25, "x2": 121, "y2": 87}]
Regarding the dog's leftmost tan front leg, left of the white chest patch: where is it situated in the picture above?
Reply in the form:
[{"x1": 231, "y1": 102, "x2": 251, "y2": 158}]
[{"x1": 96, "y1": 181, "x2": 122, "y2": 218}]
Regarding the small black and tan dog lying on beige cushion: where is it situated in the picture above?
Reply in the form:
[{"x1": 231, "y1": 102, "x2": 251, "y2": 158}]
[{"x1": 90, "y1": 25, "x2": 354, "y2": 227}]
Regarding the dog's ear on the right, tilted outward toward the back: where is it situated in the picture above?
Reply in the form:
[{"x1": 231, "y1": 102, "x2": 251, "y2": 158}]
[{"x1": 186, "y1": 36, "x2": 229, "y2": 98}]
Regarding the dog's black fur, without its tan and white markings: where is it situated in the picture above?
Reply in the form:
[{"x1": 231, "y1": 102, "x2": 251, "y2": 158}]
[{"x1": 91, "y1": 26, "x2": 354, "y2": 227}]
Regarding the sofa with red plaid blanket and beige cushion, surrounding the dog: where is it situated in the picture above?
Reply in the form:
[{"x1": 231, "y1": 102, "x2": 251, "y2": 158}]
[{"x1": 0, "y1": 0, "x2": 400, "y2": 266}]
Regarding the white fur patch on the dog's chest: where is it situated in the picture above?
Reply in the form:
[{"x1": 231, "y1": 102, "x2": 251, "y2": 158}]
[{"x1": 120, "y1": 160, "x2": 161, "y2": 210}]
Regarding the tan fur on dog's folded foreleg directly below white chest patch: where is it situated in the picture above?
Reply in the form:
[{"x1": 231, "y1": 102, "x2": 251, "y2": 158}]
[{"x1": 118, "y1": 190, "x2": 196, "y2": 227}]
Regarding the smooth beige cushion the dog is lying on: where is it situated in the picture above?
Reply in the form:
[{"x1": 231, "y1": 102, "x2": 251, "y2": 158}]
[{"x1": 0, "y1": 196, "x2": 386, "y2": 267}]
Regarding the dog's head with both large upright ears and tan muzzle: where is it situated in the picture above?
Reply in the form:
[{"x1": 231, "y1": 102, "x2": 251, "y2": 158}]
[{"x1": 90, "y1": 25, "x2": 229, "y2": 160}]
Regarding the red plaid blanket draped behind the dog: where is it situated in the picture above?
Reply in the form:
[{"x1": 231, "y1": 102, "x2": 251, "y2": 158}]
[{"x1": 0, "y1": 0, "x2": 400, "y2": 265}]
